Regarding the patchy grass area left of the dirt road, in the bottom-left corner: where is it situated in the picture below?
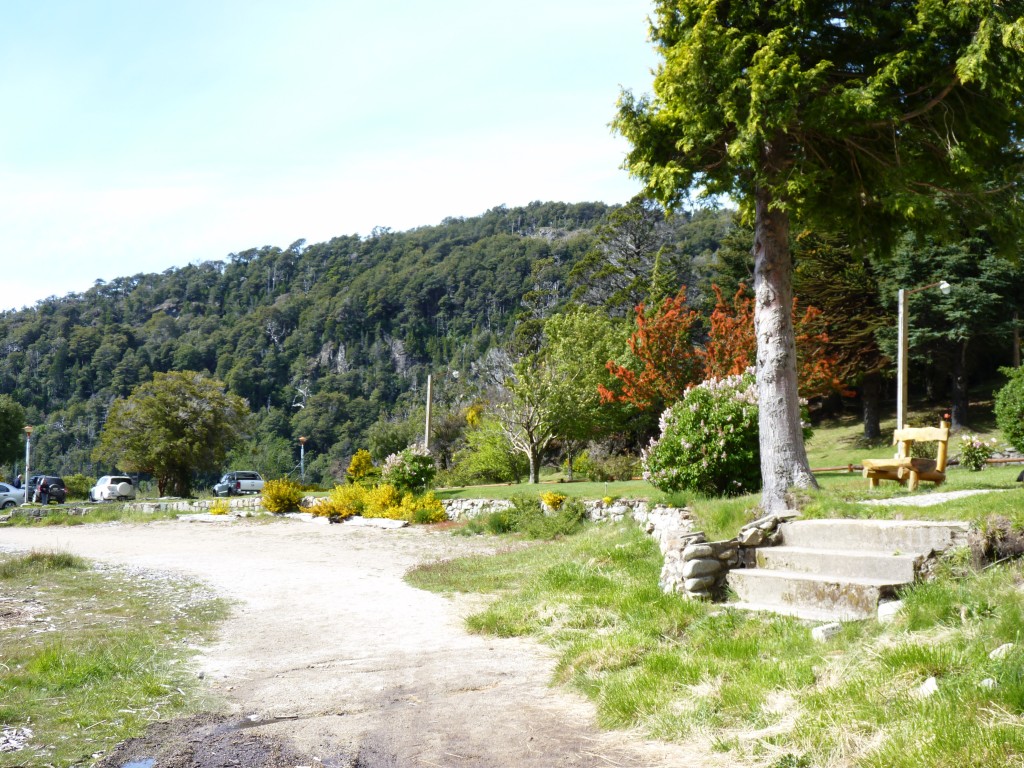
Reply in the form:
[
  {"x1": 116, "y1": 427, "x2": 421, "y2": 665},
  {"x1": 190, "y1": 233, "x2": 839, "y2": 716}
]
[{"x1": 0, "y1": 553, "x2": 226, "y2": 768}]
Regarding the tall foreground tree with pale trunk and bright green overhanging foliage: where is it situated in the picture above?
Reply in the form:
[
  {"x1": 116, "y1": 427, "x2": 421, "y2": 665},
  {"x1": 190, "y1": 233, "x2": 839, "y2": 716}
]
[{"x1": 615, "y1": 0, "x2": 1024, "y2": 518}]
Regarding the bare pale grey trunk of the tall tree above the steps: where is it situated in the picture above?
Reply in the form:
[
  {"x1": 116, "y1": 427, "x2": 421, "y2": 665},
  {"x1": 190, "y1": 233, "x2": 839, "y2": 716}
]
[{"x1": 754, "y1": 177, "x2": 817, "y2": 513}]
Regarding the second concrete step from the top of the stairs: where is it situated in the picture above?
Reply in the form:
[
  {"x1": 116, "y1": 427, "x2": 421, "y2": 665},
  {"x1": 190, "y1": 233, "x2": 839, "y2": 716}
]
[{"x1": 757, "y1": 545, "x2": 924, "y2": 584}]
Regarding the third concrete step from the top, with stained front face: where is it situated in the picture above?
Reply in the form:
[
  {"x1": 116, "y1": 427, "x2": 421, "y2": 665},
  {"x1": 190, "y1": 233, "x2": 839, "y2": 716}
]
[{"x1": 728, "y1": 568, "x2": 900, "y2": 621}]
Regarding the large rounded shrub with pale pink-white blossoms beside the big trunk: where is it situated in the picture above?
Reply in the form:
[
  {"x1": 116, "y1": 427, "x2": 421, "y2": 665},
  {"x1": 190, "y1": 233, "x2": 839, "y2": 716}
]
[{"x1": 643, "y1": 372, "x2": 761, "y2": 496}]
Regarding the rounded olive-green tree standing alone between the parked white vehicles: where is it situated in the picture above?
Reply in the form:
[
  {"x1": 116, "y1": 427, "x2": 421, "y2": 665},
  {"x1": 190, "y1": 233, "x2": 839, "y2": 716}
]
[{"x1": 93, "y1": 371, "x2": 249, "y2": 496}]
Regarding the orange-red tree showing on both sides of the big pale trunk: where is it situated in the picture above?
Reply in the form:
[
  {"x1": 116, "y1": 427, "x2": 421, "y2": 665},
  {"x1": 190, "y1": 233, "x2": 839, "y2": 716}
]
[{"x1": 697, "y1": 285, "x2": 844, "y2": 397}]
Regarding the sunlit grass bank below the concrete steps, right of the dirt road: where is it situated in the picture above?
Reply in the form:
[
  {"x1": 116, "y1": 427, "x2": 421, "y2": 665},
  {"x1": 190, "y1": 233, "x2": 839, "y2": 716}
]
[{"x1": 408, "y1": 524, "x2": 1024, "y2": 768}]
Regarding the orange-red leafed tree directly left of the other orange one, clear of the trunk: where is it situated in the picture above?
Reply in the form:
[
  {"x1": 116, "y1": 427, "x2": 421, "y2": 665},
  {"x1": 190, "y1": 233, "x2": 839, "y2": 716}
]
[{"x1": 598, "y1": 287, "x2": 703, "y2": 410}]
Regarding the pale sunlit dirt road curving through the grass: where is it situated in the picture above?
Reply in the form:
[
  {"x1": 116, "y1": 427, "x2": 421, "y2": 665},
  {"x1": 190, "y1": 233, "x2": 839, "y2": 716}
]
[{"x1": 0, "y1": 521, "x2": 708, "y2": 768}]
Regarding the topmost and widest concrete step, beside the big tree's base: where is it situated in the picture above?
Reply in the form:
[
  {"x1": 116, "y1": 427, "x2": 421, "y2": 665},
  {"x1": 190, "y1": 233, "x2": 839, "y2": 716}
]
[{"x1": 779, "y1": 519, "x2": 970, "y2": 555}]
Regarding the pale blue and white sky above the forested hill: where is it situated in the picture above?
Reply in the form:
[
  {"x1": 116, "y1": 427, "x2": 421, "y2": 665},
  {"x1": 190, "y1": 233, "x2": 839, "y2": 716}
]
[{"x1": 0, "y1": 0, "x2": 657, "y2": 310}]
